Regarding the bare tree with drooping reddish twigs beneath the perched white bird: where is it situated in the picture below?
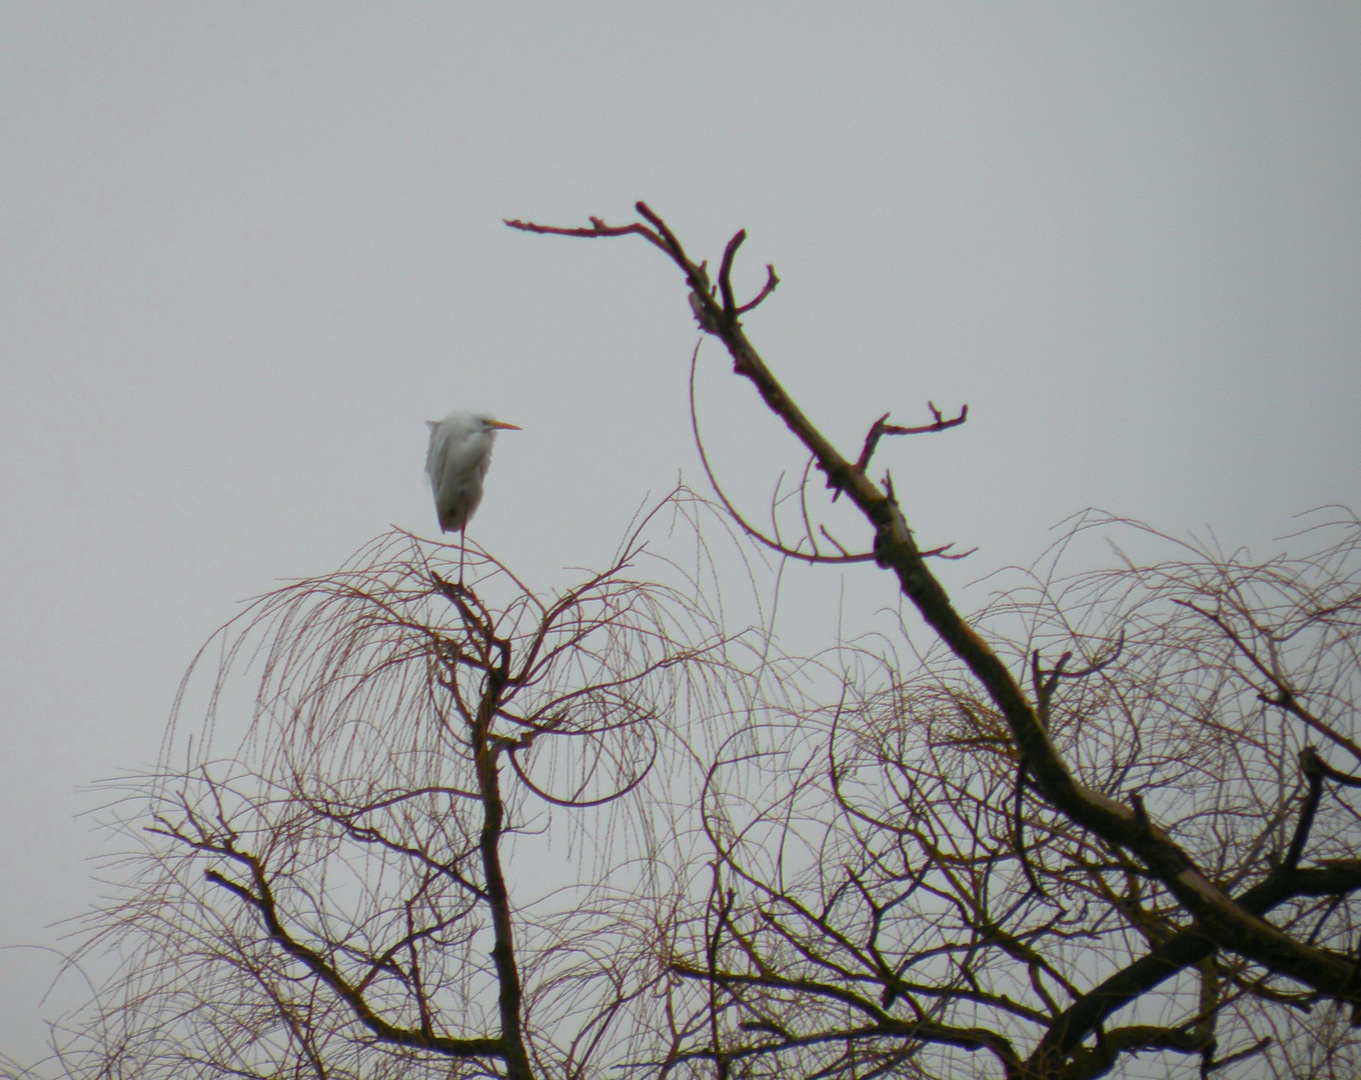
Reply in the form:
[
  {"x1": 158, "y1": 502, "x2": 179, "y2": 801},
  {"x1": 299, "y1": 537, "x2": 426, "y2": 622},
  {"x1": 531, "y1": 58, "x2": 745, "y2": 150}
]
[{"x1": 47, "y1": 516, "x2": 745, "y2": 1080}]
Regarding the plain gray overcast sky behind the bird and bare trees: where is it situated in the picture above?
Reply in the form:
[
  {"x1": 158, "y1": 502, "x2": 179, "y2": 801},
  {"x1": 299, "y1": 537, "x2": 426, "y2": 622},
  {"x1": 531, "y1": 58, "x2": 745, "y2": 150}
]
[{"x1": 0, "y1": 0, "x2": 1361, "y2": 1056}]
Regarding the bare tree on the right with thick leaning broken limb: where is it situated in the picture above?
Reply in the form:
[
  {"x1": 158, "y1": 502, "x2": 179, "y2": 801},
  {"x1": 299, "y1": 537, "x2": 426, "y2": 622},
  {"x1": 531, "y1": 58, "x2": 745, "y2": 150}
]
[{"x1": 508, "y1": 203, "x2": 1361, "y2": 1077}]
